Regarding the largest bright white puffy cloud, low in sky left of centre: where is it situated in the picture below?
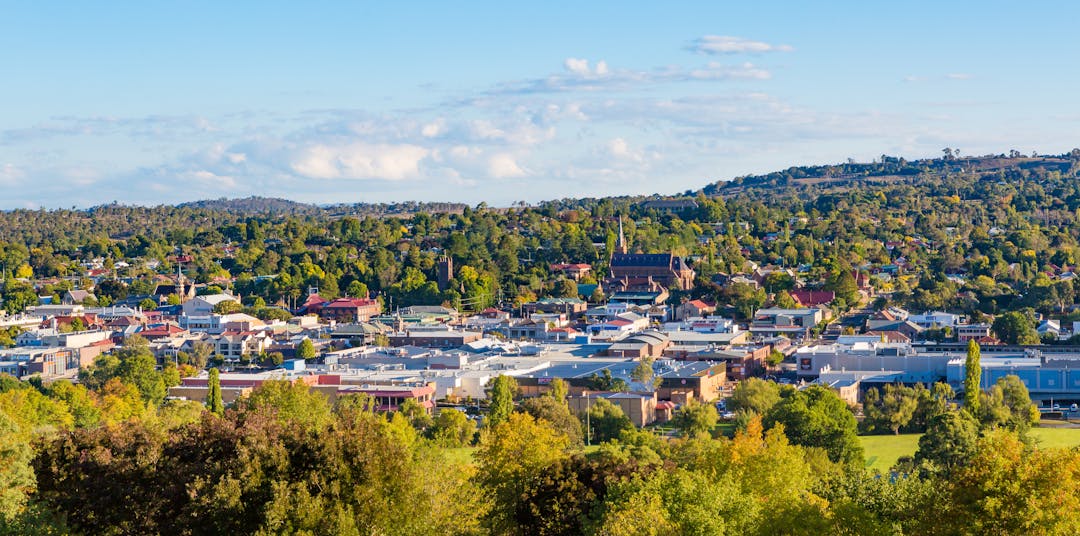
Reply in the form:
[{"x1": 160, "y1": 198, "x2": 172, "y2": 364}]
[{"x1": 291, "y1": 143, "x2": 431, "y2": 180}]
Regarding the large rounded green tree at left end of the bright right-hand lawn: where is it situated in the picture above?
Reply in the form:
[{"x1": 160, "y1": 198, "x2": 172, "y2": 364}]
[{"x1": 764, "y1": 385, "x2": 863, "y2": 464}]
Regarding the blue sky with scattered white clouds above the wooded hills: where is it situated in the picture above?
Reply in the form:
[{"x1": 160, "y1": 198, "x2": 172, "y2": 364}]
[{"x1": 0, "y1": 0, "x2": 1080, "y2": 209}]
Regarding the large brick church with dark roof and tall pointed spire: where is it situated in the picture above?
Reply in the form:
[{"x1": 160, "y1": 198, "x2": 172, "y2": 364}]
[{"x1": 604, "y1": 216, "x2": 694, "y2": 292}]
